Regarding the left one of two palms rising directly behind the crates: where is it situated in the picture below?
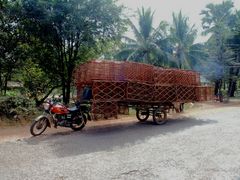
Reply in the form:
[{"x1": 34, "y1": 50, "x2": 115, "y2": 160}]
[{"x1": 118, "y1": 8, "x2": 170, "y2": 65}]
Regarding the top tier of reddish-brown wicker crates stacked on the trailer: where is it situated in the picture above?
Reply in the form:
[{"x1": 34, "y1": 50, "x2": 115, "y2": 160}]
[{"x1": 74, "y1": 60, "x2": 200, "y2": 85}]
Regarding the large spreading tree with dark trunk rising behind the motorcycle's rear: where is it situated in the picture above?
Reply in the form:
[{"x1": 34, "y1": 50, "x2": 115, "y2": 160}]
[{"x1": 22, "y1": 0, "x2": 124, "y2": 103}]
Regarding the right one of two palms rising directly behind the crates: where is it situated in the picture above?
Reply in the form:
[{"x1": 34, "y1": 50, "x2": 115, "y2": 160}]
[{"x1": 171, "y1": 11, "x2": 206, "y2": 69}]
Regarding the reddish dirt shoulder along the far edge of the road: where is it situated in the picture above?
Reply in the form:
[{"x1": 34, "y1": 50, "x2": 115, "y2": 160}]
[{"x1": 0, "y1": 100, "x2": 240, "y2": 143}]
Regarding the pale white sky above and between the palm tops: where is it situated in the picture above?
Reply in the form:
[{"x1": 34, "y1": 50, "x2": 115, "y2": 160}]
[{"x1": 119, "y1": 0, "x2": 240, "y2": 42}]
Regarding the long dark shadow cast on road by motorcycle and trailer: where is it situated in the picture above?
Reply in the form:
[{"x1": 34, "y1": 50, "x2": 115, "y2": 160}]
[{"x1": 25, "y1": 118, "x2": 217, "y2": 157}]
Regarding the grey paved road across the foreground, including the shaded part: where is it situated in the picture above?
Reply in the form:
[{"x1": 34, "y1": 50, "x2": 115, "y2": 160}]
[{"x1": 0, "y1": 107, "x2": 240, "y2": 180}]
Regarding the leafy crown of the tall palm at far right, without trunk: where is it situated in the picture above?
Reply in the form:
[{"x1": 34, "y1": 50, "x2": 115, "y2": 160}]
[{"x1": 201, "y1": 1, "x2": 234, "y2": 63}]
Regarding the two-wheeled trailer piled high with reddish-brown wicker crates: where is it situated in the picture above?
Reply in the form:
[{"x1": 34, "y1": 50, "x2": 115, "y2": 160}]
[{"x1": 74, "y1": 60, "x2": 213, "y2": 125}]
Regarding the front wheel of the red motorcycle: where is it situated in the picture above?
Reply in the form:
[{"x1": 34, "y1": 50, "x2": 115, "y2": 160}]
[{"x1": 30, "y1": 117, "x2": 48, "y2": 136}]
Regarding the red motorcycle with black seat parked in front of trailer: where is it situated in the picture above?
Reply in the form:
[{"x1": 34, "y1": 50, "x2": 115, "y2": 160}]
[{"x1": 30, "y1": 100, "x2": 91, "y2": 136}]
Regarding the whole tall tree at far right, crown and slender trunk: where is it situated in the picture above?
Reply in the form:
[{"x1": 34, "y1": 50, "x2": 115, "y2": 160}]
[{"x1": 201, "y1": 0, "x2": 234, "y2": 95}]
